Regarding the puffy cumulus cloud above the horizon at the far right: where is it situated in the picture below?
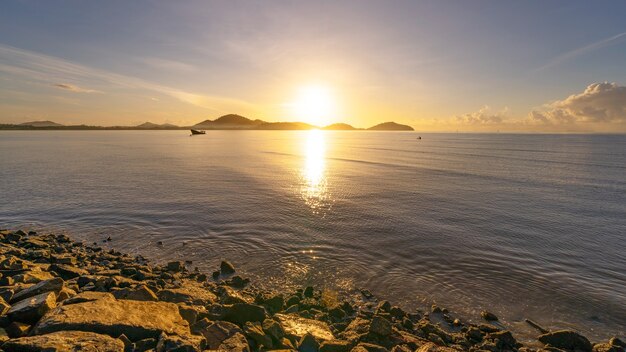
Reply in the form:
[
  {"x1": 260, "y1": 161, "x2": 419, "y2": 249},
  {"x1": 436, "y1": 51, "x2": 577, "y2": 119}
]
[{"x1": 528, "y1": 82, "x2": 626, "y2": 124}]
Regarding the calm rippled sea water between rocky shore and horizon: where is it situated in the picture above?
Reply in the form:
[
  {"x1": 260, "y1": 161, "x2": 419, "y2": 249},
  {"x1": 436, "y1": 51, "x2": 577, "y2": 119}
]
[{"x1": 0, "y1": 131, "x2": 626, "y2": 340}]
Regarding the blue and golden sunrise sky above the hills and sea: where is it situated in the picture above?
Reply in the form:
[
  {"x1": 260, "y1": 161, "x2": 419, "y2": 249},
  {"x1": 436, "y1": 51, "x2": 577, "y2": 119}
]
[{"x1": 0, "y1": 0, "x2": 626, "y2": 133}]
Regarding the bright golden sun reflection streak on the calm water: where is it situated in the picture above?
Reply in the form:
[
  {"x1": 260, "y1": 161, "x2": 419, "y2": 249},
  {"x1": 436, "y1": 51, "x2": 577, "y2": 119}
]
[{"x1": 300, "y1": 130, "x2": 331, "y2": 214}]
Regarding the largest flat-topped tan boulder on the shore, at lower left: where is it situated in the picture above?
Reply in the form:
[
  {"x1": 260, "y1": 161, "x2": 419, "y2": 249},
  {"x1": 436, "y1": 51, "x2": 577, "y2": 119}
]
[{"x1": 34, "y1": 299, "x2": 189, "y2": 341}]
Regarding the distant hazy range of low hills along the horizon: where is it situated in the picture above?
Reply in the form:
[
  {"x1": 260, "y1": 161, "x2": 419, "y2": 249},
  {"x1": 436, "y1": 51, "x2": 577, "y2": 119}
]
[{"x1": 0, "y1": 114, "x2": 413, "y2": 131}]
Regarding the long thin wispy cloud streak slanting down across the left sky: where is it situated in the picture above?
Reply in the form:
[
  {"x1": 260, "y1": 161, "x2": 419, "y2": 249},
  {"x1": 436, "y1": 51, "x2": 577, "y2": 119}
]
[{"x1": 0, "y1": 44, "x2": 255, "y2": 113}]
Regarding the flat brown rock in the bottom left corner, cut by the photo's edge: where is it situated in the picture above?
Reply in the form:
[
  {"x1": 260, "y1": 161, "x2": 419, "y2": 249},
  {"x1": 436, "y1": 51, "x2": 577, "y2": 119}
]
[{"x1": 2, "y1": 331, "x2": 124, "y2": 352}]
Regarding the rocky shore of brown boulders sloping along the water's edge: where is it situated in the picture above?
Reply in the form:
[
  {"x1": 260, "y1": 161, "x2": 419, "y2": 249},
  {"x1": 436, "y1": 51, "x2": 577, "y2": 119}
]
[{"x1": 0, "y1": 230, "x2": 626, "y2": 352}]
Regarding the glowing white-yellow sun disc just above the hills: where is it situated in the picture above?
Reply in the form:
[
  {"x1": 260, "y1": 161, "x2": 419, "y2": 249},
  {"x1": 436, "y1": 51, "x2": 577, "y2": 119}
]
[{"x1": 289, "y1": 85, "x2": 336, "y2": 126}]
